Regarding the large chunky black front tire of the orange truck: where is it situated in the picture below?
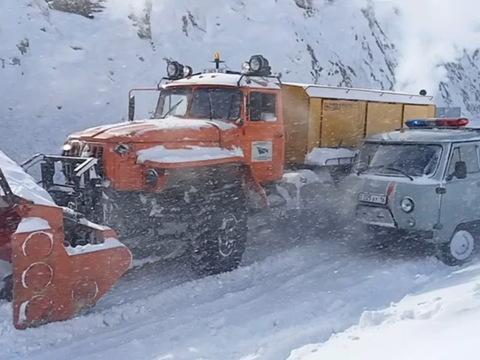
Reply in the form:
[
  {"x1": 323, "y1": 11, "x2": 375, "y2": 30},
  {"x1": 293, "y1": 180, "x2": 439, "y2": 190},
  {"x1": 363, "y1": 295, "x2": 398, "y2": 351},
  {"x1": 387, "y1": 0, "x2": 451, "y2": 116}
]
[{"x1": 190, "y1": 176, "x2": 248, "y2": 275}]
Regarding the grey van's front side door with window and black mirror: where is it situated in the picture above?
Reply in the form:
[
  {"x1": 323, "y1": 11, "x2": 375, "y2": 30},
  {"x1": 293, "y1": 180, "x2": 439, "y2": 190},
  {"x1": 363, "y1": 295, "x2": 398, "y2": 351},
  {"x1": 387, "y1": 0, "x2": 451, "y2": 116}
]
[{"x1": 440, "y1": 143, "x2": 480, "y2": 236}]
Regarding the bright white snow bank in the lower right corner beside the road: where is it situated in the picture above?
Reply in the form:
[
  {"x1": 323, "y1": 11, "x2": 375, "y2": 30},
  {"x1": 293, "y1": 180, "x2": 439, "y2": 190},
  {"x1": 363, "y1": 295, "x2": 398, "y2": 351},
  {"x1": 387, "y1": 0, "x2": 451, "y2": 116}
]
[{"x1": 289, "y1": 265, "x2": 480, "y2": 360}]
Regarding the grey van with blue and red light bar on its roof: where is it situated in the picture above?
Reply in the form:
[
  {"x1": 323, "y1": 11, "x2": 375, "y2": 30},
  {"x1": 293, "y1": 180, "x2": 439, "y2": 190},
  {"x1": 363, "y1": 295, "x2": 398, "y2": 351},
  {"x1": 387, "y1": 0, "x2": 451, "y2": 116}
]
[{"x1": 350, "y1": 118, "x2": 480, "y2": 265}]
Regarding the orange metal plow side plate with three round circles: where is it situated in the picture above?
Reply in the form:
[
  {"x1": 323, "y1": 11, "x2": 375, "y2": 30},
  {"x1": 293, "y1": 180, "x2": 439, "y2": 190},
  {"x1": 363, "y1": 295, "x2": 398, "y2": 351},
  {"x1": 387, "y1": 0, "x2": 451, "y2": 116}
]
[{"x1": 11, "y1": 206, "x2": 132, "y2": 329}]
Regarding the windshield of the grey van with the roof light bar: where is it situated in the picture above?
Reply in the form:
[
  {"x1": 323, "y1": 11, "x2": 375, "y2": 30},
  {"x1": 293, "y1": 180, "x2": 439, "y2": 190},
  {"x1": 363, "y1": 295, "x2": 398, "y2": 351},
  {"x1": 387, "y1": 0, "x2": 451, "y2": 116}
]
[{"x1": 356, "y1": 143, "x2": 442, "y2": 177}]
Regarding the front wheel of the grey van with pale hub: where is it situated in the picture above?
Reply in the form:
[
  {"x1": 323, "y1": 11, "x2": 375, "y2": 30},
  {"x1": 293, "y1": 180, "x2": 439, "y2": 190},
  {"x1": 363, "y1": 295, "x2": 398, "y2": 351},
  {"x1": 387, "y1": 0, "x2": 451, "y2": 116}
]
[{"x1": 436, "y1": 229, "x2": 477, "y2": 266}]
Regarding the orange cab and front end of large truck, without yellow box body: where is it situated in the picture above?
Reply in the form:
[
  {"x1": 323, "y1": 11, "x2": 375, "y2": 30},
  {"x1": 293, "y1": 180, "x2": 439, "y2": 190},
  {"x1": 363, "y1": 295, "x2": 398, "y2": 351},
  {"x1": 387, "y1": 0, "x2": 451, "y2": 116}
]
[{"x1": 42, "y1": 55, "x2": 285, "y2": 274}]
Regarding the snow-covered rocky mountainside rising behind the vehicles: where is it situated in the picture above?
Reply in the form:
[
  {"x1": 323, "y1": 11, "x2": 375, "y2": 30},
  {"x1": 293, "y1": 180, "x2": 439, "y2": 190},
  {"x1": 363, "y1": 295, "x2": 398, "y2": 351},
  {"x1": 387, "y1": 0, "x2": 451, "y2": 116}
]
[{"x1": 0, "y1": 0, "x2": 479, "y2": 160}]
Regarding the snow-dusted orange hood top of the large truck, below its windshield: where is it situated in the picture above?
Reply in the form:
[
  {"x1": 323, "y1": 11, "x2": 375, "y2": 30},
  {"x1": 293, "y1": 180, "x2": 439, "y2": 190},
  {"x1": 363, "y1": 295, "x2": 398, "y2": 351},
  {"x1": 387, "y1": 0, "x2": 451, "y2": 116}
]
[{"x1": 69, "y1": 117, "x2": 237, "y2": 143}]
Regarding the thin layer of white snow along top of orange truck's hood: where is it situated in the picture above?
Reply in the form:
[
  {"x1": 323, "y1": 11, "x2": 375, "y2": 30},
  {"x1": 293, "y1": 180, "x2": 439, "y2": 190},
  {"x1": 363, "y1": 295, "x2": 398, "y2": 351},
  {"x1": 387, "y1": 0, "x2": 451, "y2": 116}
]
[{"x1": 71, "y1": 116, "x2": 237, "y2": 138}]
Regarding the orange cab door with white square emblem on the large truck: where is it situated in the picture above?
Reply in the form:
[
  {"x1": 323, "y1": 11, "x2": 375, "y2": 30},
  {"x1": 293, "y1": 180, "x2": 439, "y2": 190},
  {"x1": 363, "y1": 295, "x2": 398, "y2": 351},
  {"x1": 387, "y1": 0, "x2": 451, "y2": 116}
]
[{"x1": 243, "y1": 89, "x2": 285, "y2": 182}]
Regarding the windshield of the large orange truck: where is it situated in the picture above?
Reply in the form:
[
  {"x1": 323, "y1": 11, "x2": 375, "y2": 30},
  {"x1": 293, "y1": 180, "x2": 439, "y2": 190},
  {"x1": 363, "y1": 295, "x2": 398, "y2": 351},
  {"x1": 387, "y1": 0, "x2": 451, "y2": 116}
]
[{"x1": 154, "y1": 88, "x2": 243, "y2": 120}]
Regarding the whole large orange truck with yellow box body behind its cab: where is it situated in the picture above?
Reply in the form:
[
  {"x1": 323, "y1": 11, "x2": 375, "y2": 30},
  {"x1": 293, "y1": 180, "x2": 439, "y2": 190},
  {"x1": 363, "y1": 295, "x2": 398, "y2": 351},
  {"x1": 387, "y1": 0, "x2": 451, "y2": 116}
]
[{"x1": 29, "y1": 55, "x2": 435, "y2": 274}]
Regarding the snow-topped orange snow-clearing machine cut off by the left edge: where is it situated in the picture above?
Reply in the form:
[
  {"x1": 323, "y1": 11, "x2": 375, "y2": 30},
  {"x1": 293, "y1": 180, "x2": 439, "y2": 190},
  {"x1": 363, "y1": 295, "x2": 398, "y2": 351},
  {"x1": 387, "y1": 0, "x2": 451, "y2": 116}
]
[{"x1": 0, "y1": 151, "x2": 132, "y2": 329}]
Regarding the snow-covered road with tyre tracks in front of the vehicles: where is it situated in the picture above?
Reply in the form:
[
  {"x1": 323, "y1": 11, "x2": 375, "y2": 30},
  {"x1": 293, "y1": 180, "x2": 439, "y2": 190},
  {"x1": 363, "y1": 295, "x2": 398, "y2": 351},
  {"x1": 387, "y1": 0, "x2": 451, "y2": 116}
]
[{"x1": 0, "y1": 224, "x2": 453, "y2": 360}]
